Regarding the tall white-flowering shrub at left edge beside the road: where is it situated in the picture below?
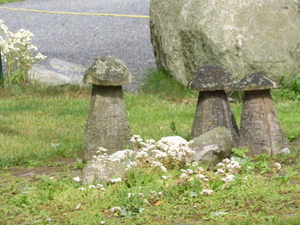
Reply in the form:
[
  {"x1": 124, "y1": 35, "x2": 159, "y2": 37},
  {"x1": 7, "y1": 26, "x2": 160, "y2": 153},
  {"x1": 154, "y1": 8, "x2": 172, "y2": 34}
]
[{"x1": 0, "y1": 20, "x2": 46, "y2": 86}]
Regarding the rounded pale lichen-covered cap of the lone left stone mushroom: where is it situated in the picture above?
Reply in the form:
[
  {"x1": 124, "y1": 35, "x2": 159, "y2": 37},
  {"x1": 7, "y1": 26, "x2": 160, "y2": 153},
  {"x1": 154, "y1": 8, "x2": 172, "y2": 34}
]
[{"x1": 83, "y1": 56, "x2": 132, "y2": 86}]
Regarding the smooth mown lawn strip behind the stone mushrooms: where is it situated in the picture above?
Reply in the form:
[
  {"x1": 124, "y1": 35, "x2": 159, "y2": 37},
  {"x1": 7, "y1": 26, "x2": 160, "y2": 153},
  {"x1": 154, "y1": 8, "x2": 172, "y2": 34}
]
[{"x1": 0, "y1": 71, "x2": 300, "y2": 167}]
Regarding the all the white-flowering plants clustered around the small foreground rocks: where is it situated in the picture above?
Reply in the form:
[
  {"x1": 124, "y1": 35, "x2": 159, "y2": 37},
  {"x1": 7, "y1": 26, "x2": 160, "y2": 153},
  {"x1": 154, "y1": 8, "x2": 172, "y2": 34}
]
[{"x1": 91, "y1": 135, "x2": 240, "y2": 195}]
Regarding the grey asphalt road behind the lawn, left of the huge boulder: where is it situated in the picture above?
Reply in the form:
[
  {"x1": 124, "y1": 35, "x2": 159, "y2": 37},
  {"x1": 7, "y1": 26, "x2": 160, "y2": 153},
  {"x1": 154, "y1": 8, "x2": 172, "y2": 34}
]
[{"x1": 0, "y1": 0, "x2": 155, "y2": 76}]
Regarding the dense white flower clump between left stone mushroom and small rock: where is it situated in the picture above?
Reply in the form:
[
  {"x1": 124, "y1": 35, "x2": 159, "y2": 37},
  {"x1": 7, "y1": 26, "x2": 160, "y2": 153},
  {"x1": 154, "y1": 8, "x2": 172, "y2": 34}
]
[{"x1": 94, "y1": 135, "x2": 195, "y2": 172}]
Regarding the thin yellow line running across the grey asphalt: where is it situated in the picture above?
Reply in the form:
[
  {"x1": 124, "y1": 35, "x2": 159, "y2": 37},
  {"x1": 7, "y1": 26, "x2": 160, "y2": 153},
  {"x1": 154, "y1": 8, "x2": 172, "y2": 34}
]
[{"x1": 0, "y1": 6, "x2": 150, "y2": 18}]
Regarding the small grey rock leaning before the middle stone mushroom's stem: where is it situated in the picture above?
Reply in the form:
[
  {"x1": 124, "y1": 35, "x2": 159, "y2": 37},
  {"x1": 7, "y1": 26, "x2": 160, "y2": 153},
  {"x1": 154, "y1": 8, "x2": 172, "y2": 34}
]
[{"x1": 189, "y1": 127, "x2": 233, "y2": 168}]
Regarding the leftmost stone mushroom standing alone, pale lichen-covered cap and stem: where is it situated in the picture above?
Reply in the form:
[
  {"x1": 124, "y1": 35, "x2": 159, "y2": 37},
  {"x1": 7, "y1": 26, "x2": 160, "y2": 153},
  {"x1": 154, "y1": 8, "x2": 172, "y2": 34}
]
[{"x1": 83, "y1": 56, "x2": 132, "y2": 161}]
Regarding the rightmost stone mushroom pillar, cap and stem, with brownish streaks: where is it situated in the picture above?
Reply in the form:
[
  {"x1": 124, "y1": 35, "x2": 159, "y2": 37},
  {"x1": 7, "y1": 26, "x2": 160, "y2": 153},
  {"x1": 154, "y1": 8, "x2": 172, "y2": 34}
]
[{"x1": 235, "y1": 73, "x2": 287, "y2": 155}]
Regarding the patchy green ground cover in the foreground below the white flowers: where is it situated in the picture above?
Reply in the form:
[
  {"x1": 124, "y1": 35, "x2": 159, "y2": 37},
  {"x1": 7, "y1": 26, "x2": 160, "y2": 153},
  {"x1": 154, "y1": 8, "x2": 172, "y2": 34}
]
[{"x1": 0, "y1": 152, "x2": 300, "y2": 225}]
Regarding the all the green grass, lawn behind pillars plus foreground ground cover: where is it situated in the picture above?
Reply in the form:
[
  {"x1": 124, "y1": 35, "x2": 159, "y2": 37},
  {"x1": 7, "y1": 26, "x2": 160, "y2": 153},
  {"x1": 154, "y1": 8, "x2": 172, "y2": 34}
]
[{"x1": 0, "y1": 71, "x2": 300, "y2": 225}]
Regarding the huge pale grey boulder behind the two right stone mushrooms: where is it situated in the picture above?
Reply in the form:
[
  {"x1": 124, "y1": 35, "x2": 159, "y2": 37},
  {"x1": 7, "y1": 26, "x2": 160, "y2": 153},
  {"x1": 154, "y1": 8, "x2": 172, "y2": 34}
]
[{"x1": 150, "y1": 0, "x2": 300, "y2": 84}]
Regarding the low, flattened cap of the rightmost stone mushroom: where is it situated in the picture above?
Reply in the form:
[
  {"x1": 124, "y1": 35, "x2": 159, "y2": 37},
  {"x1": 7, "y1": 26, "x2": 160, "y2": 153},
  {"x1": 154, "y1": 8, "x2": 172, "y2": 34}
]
[{"x1": 234, "y1": 73, "x2": 280, "y2": 91}]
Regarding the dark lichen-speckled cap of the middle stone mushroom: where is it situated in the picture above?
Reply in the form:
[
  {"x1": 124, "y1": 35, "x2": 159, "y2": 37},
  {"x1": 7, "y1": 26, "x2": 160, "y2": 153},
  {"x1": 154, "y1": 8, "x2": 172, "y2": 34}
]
[{"x1": 187, "y1": 65, "x2": 232, "y2": 91}]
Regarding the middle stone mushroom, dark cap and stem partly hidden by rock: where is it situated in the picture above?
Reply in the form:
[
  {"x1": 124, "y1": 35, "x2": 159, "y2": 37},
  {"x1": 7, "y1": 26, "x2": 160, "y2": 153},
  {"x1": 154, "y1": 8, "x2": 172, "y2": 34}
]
[{"x1": 187, "y1": 65, "x2": 239, "y2": 147}]
